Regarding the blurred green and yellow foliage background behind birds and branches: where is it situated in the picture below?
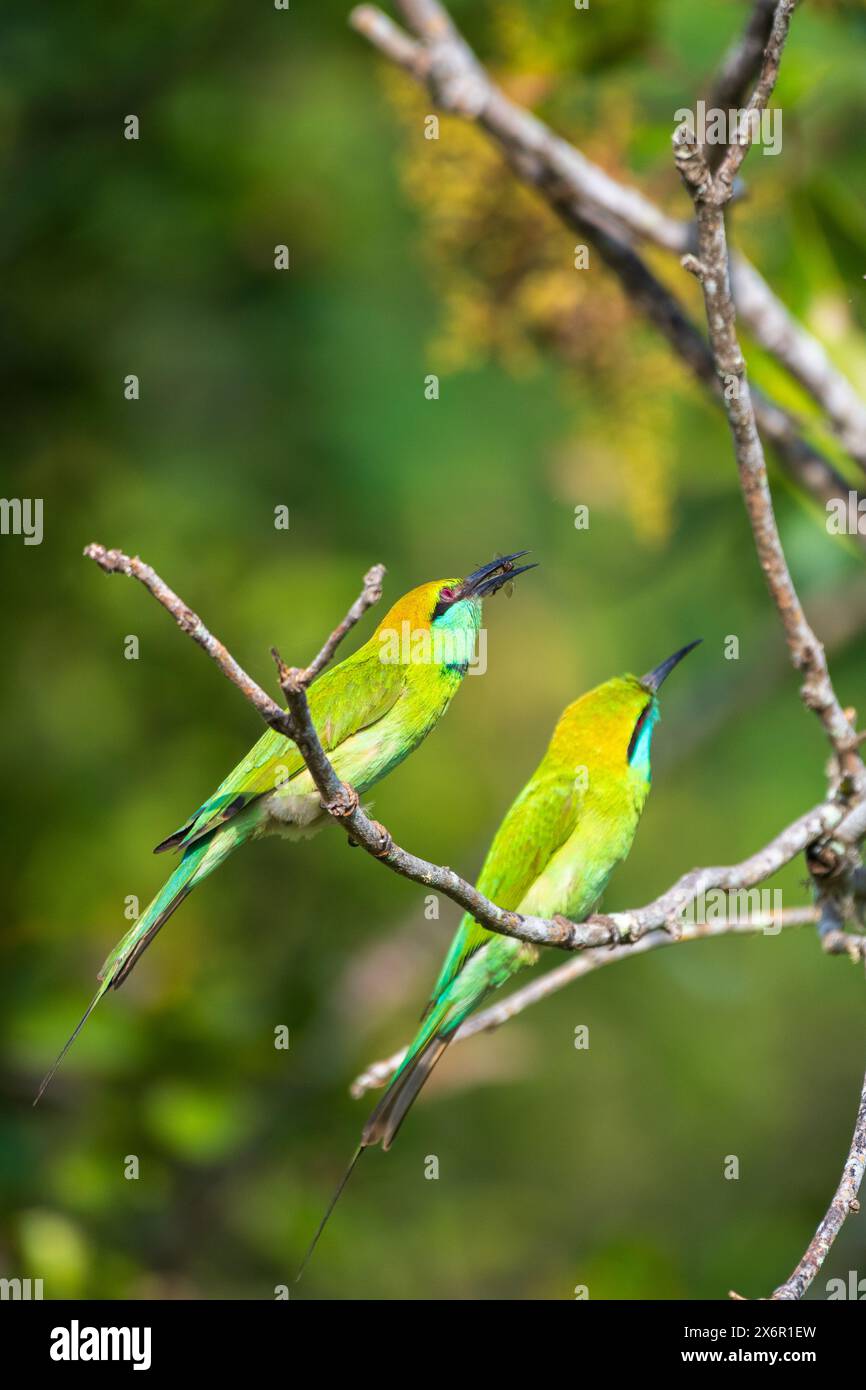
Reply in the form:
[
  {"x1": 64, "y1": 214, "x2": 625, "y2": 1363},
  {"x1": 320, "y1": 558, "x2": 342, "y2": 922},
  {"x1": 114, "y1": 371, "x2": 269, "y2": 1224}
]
[{"x1": 0, "y1": 0, "x2": 866, "y2": 1298}]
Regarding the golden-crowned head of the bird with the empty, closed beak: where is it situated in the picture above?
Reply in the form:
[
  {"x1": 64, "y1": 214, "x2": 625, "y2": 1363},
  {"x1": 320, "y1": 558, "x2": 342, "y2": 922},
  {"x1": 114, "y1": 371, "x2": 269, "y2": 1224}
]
[{"x1": 555, "y1": 638, "x2": 701, "y2": 781}]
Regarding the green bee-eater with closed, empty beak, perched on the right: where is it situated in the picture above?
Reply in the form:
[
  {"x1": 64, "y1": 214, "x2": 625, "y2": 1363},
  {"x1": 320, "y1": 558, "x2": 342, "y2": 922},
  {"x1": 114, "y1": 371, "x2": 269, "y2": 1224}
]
[{"x1": 299, "y1": 642, "x2": 698, "y2": 1277}]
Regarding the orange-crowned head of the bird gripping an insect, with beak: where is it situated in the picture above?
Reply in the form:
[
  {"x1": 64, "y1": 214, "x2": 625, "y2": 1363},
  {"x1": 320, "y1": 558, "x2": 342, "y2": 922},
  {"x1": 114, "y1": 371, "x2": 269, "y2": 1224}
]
[{"x1": 374, "y1": 550, "x2": 535, "y2": 666}]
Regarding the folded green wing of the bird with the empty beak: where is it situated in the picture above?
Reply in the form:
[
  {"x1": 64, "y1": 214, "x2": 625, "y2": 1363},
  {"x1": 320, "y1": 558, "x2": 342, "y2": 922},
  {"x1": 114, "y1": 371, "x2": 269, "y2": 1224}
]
[{"x1": 428, "y1": 763, "x2": 584, "y2": 1011}]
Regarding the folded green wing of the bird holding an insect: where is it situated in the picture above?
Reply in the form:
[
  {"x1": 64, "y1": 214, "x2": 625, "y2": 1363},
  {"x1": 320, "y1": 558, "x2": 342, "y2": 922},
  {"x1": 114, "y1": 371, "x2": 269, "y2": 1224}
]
[{"x1": 156, "y1": 642, "x2": 406, "y2": 853}]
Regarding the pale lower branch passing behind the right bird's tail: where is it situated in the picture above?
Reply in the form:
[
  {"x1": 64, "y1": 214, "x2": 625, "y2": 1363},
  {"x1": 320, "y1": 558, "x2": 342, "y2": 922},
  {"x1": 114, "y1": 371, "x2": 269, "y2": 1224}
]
[{"x1": 349, "y1": 908, "x2": 817, "y2": 1101}]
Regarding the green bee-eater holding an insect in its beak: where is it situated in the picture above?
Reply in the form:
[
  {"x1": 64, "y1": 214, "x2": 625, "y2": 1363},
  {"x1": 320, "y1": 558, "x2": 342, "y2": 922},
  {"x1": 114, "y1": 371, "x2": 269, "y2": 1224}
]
[{"x1": 33, "y1": 550, "x2": 535, "y2": 1104}]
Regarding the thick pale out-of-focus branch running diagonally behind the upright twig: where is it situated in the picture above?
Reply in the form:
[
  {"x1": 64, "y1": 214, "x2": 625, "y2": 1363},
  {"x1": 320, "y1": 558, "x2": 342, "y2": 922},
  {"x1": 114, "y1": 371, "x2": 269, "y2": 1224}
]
[{"x1": 350, "y1": 0, "x2": 866, "y2": 478}]
